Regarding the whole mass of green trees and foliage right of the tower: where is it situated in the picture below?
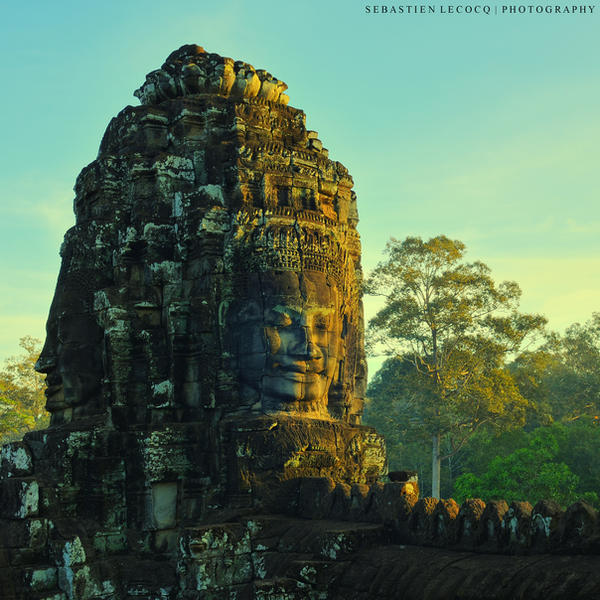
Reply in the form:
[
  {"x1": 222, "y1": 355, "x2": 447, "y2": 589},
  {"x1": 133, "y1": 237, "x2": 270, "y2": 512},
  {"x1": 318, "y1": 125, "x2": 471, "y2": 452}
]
[{"x1": 365, "y1": 236, "x2": 600, "y2": 507}]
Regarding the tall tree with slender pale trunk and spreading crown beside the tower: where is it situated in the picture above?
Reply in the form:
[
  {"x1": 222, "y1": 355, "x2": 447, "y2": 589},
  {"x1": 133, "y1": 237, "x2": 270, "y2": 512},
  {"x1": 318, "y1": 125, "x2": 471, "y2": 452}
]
[{"x1": 366, "y1": 236, "x2": 546, "y2": 497}]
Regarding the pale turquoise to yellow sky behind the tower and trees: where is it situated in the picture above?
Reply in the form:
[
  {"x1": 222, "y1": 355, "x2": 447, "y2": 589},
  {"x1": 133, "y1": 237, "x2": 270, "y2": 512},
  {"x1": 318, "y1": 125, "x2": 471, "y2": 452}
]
[{"x1": 0, "y1": 0, "x2": 600, "y2": 374}]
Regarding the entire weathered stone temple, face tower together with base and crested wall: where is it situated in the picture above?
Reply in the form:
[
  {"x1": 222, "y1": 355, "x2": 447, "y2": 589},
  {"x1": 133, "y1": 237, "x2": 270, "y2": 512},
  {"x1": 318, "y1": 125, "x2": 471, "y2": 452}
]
[{"x1": 0, "y1": 46, "x2": 600, "y2": 600}]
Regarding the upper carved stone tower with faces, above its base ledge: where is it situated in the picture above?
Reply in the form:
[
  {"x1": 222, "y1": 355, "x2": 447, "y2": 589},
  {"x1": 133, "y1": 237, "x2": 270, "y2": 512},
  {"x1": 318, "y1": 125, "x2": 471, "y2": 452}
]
[{"x1": 38, "y1": 45, "x2": 366, "y2": 424}]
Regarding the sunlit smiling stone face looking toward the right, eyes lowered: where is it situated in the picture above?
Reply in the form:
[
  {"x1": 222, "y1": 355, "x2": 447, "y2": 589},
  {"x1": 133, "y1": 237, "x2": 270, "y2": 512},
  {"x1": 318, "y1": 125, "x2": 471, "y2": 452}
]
[{"x1": 228, "y1": 272, "x2": 342, "y2": 416}]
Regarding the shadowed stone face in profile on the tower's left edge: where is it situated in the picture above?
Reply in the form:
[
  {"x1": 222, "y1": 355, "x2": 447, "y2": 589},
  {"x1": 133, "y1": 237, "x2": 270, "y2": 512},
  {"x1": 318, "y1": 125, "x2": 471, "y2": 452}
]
[{"x1": 36, "y1": 270, "x2": 102, "y2": 413}]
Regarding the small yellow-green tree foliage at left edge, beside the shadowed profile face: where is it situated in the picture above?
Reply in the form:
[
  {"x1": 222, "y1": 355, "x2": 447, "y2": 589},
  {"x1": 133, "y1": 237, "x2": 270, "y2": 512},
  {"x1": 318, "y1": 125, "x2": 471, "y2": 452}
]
[{"x1": 0, "y1": 336, "x2": 49, "y2": 444}]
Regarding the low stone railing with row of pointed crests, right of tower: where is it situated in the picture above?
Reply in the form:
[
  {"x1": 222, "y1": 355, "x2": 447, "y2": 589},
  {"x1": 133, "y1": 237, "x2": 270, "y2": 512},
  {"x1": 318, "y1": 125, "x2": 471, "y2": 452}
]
[{"x1": 288, "y1": 477, "x2": 600, "y2": 554}]
